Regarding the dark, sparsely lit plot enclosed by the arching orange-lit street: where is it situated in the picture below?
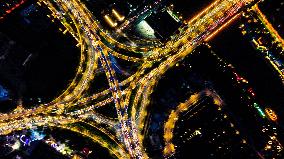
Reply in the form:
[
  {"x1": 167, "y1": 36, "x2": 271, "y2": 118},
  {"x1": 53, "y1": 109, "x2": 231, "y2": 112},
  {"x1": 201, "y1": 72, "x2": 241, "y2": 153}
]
[{"x1": 173, "y1": 97, "x2": 257, "y2": 159}]
